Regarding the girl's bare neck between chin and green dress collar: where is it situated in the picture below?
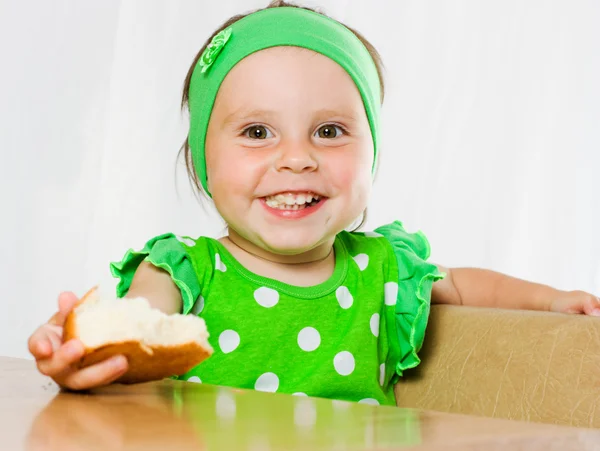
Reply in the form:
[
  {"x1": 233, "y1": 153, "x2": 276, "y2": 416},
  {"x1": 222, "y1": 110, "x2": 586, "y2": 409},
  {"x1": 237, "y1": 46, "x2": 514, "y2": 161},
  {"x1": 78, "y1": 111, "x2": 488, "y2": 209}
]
[{"x1": 226, "y1": 228, "x2": 334, "y2": 265}]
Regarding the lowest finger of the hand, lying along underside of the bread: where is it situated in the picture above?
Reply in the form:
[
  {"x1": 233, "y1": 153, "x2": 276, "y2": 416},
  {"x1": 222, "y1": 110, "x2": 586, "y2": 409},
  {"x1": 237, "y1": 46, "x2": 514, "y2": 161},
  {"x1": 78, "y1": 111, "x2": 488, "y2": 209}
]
[{"x1": 59, "y1": 355, "x2": 128, "y2": 390}]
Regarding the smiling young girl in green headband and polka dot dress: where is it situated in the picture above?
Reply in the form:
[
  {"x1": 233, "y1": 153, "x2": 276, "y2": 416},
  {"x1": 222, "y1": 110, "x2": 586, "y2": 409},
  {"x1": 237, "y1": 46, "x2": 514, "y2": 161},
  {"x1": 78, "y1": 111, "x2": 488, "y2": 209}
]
[{"x1": 29, "y1": 1, "x2": 600, "y2": 404}]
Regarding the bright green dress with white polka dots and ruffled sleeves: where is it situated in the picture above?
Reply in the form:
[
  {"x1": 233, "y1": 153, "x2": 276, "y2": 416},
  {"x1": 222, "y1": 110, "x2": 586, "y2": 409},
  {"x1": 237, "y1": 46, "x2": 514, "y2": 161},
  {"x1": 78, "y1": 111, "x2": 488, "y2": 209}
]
[{"x1": 111, "y1": 222, "x2": 443, "y2": 405}]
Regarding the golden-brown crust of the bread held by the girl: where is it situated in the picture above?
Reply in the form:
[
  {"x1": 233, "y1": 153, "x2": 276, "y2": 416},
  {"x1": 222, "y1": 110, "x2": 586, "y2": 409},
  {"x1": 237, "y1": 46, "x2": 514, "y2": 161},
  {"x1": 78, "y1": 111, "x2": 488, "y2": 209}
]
[{"x1": 63, "y1": 287, "x2": 213, "y2": 384}]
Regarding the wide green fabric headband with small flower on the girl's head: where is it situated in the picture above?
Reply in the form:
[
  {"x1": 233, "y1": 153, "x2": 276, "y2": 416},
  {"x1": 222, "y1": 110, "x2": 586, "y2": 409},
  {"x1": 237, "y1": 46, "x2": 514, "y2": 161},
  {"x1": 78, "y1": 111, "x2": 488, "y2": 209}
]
[{"x1": 188, "y1": 7, "x2": 381, "y2": 195}]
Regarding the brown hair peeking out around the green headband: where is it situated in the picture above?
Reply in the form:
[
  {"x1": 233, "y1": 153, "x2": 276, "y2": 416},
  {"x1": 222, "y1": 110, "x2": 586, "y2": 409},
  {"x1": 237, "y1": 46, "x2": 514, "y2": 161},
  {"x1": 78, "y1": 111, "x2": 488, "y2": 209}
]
[{"x1": 178, "y1": 0, "x2": 385, "y2": 230}]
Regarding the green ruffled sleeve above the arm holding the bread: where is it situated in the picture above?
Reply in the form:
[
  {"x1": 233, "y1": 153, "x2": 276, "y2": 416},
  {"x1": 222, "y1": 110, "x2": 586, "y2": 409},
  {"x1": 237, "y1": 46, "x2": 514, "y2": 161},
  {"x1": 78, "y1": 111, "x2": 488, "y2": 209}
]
[{"x1": 110, "y1": 233, "x2": 201, "y2": 311}]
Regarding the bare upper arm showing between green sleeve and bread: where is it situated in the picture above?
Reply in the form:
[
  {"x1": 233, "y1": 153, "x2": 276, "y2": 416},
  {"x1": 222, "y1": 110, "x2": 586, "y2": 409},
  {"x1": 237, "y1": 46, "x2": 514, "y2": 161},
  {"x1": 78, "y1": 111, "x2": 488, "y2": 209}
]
[{"x1": 126, "y1": 261, "x2": 183, "y2": 315}]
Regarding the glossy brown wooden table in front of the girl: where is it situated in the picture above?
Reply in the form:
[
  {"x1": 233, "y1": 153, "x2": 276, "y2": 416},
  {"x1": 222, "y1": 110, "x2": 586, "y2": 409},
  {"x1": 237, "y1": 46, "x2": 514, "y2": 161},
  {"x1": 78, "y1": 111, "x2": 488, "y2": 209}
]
[{"x1": 0, "y1": 357, "x2": 600, "y2": 451}]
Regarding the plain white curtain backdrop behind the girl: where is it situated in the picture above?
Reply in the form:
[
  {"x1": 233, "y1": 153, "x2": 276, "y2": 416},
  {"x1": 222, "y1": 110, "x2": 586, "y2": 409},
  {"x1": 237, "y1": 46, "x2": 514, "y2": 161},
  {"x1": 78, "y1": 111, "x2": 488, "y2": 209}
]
[{"x1": 0, "y1": 0, "x2": 600, "y2": 357}]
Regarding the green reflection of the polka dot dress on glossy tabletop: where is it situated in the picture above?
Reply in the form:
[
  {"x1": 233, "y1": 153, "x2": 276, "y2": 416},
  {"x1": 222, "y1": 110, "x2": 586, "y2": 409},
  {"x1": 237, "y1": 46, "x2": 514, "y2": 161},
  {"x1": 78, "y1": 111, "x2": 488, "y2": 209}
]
[{"x1": 169, "y1": 382, "x2": 421, "y2": 451}]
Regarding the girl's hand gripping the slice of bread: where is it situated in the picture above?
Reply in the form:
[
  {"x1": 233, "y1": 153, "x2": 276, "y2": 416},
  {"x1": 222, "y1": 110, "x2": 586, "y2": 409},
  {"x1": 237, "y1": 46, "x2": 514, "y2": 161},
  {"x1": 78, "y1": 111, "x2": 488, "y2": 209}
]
[{"x1": 28, "y1": 293, "x2": 127, "y2": 390}]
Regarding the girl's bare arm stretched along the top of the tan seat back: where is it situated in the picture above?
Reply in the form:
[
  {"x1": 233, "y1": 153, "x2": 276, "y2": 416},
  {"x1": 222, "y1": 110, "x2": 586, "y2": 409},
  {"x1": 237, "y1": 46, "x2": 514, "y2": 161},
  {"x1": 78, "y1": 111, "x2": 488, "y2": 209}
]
[{"x1": 431, "y1": 265, "x2": 600, "y2": 315}]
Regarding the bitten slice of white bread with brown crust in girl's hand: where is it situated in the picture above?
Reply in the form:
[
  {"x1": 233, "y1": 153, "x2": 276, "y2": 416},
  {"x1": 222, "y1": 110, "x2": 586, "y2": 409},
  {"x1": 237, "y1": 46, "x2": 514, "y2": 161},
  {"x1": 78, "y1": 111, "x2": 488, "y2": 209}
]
[{"x1": 63, "y1": 288, "x2": 213, "y2": 384}]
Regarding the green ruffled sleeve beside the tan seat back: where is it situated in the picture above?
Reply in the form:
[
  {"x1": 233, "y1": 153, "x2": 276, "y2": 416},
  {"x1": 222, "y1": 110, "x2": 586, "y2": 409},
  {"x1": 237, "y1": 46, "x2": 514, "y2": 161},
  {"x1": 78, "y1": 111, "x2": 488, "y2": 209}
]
[{"x1": 375, "y1": 221, "x2": 445, "y2": 382}]
